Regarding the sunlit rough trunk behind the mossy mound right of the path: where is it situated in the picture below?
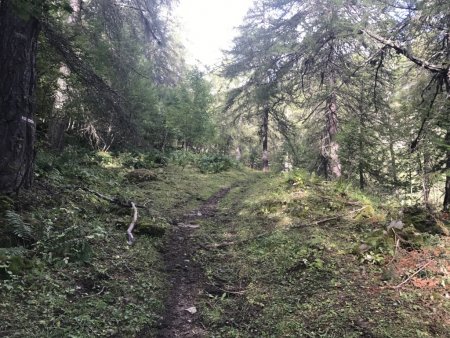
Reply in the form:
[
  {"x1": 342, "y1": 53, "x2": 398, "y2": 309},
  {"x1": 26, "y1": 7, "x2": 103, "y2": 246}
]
[{"x1": 322, "y1": 94, "x2": 341, "y2": 179}]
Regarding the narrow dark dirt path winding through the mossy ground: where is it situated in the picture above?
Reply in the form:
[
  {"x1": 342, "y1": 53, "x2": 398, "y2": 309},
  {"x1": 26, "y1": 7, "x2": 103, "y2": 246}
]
[{"x1": 158, "y1": 188, "x2": 230, "y2": 338}]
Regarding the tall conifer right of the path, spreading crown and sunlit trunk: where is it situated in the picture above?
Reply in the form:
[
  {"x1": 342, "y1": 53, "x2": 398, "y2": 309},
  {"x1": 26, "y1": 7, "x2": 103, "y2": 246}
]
[{"x1": 225, "y1": 0, "x2": 384, "y2": 178}]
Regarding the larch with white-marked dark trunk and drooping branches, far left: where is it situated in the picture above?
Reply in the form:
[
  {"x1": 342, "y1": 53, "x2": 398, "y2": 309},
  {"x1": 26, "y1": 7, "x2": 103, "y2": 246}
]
[{"x1": 0, "y1": 0, "x2": 176, "y2": 193}]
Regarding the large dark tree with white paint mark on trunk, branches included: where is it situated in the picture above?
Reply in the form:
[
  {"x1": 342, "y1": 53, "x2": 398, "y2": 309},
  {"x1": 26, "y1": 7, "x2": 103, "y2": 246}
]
[{"x1": 0, "y1": 0, "x2": 177, "y2": 193}]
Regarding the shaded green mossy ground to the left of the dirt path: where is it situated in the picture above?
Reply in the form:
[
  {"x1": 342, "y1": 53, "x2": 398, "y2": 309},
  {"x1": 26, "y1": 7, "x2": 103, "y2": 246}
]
[{"x1": 0, "y1": 149, "x2": 245, "y2": 337}]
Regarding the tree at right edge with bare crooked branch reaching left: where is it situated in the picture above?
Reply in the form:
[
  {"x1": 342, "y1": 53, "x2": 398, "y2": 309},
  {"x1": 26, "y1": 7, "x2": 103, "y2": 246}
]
[{"x1": 361, "y1": 0, "x2": 450, "y2": 211}]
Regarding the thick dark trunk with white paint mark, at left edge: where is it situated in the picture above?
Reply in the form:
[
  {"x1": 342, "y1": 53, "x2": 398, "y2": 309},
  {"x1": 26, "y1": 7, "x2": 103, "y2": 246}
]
[{"x1": 0, "y1": 0, "x2": 39, "y2": 193}]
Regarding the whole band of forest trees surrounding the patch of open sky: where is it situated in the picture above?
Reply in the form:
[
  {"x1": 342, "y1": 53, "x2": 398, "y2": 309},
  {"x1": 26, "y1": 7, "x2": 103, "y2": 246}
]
[{"x1": 0, "y1": 0, "x2": 450, "y2": 210}]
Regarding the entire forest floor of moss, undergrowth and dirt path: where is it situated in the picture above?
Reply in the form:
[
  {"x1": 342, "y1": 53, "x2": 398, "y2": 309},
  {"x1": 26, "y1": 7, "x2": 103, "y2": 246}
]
[{"x1": 0, "y1": 153, "x2": 450, "y2": 338}]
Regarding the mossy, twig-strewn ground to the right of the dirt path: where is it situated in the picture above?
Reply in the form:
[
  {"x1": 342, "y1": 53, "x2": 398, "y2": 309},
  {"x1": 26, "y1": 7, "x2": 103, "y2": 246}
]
[{"x1": 192, "y1": 174, "x2": 450, "y2": 337}]
